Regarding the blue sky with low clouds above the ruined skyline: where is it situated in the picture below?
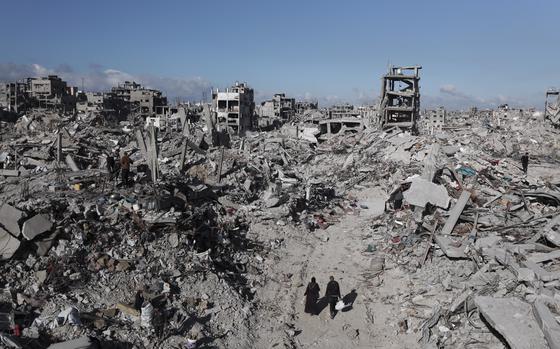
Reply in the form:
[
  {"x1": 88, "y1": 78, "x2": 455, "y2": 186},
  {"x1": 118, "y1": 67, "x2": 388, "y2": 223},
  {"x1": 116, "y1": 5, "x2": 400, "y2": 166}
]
[{"x1": 0, "y1": 0, "x2": 560, "y2": 108}]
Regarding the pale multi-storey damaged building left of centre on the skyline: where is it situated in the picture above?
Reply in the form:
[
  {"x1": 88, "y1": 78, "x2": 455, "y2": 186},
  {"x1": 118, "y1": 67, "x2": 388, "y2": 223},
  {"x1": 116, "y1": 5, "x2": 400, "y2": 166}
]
[{"x1": 212, "y1": 82, "x2": 255, "y2": 135}]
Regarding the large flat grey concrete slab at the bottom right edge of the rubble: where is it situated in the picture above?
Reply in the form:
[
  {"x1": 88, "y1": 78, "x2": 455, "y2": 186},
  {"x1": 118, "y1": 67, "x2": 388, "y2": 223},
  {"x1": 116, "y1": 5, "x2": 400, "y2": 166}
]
[{"x1": 474, "y1": 296, "x2": 548, "y2": 349}]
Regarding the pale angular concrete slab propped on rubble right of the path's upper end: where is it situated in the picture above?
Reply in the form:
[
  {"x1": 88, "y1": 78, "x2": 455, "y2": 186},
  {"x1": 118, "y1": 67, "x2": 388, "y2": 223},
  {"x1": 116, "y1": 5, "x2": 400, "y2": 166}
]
[{"x1": 403, "y1": 177, "x2": 450, "y2": 208}]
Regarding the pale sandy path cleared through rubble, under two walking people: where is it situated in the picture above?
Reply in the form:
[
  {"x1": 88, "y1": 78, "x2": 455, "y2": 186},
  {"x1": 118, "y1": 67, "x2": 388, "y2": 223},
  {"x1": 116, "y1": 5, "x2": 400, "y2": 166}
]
[{"x1": 254, "y1": 188, "x2": 418, "y2": 348}]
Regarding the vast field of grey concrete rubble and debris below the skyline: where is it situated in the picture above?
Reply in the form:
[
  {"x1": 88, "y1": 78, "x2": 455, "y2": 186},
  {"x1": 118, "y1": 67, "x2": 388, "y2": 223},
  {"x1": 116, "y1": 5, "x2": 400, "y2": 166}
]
[{"x1": 0, "y1": 108, "x2": 560, "y2": 349}]
